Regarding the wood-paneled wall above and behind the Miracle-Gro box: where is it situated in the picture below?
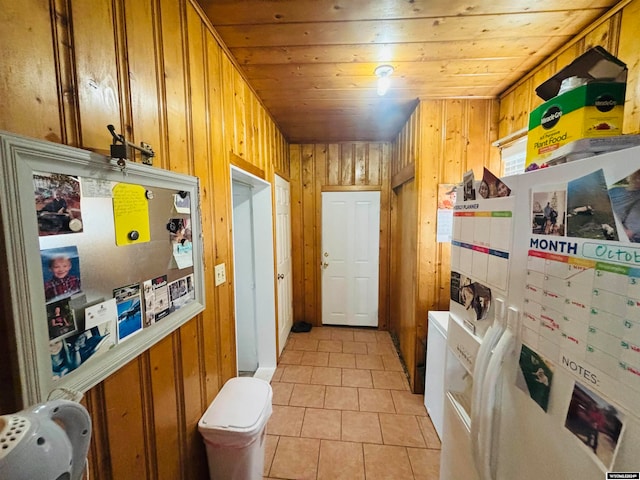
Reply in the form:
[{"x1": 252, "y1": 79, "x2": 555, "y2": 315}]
[{"x1": 499, "y1": 0, "x2": 640, "y2": 138}]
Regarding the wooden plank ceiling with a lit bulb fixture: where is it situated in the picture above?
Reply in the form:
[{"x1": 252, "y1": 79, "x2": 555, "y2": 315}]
[{"x1": 198, "y1": 0, "x2": 618, "y2": 143}]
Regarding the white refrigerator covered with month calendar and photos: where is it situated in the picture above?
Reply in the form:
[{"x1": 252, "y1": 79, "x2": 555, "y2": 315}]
[{"x1": 440, "y1": 147, "x2": 640, "y2": 480}]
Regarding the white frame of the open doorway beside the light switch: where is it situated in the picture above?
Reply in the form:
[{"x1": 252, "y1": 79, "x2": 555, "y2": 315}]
[{"x1": 231, "y1": 165, "x2": 276, "y2": 381}]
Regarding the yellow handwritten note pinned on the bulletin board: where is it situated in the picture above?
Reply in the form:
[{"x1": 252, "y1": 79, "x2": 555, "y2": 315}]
[{"x1": 113, "y1": 183, "x2": 151, "y2": 246}]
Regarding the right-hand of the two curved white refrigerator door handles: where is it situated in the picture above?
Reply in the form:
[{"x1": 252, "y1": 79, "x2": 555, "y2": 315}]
[{"x1": 478, "y1": 328, "x2": 516, "y2": 480}]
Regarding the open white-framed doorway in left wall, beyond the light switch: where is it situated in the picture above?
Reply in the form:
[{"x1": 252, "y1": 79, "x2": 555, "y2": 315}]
[{"x1": 231, "y1": 166, "x2": 276, "y2": 381}]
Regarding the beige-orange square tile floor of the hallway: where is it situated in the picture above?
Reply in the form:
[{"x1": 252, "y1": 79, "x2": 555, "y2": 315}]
[{"x1": 264, "y1": 327, "x2": 440, "y2": 480}]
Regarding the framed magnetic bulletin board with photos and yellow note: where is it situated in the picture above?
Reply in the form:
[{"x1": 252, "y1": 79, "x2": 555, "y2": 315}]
[{"x1": 0, "y1": 132, "x2": 205, "y2": 405}]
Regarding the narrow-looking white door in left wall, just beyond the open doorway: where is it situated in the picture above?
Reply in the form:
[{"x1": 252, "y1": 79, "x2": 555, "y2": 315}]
[{"x1": 275, "y1": 175, "x2": 293, "y2": 353}]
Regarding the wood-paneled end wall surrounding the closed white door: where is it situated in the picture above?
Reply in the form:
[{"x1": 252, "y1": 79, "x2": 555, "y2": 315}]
[{"x1": 289, "y1": 142, "x2": 391, "y2": 330}]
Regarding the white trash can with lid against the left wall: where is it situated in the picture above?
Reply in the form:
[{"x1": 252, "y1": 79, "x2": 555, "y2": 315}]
[{"x1": 198, "y1": 377, "x2": 273, "y2": 480}]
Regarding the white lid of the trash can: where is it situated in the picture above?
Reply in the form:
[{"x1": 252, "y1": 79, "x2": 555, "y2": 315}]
[{"x1": 198, "y1": 377, "x2": 273, "y2": 433}]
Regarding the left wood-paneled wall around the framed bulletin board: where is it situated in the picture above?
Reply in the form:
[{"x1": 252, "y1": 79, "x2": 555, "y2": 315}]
[{"x1": 0, "y1": 0, "x2": 289, "y2": 480}]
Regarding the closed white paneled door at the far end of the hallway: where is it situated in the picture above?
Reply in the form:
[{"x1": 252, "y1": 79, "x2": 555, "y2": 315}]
[{"x1": 320, "y1": 192, "x2": 380, "y2": 327}]
